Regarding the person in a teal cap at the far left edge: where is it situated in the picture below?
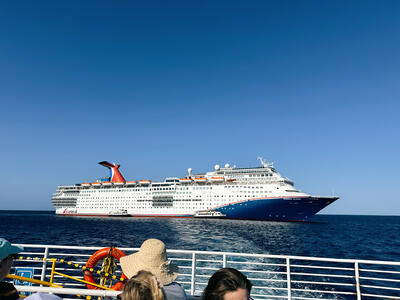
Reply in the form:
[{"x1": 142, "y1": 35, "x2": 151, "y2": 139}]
[{"x1": 0, "y1": 238, "x2": 24, "y2": 300}]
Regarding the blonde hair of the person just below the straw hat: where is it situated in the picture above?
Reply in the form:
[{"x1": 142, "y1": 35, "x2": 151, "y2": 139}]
[{"x1": 121, "y1": 270, "x2": 163, "y2": 300}]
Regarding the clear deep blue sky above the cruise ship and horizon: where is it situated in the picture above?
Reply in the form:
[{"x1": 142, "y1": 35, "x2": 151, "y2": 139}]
[{"x1": 0, "y1": 0, "x2": 400, "y2": 215}]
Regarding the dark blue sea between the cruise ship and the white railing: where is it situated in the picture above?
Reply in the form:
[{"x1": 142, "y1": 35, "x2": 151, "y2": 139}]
[{"x1": 0, "y1": 211, "x2": 400, "y2": 261}]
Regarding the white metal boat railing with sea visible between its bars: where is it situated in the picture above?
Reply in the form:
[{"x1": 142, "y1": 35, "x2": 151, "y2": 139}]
[{"x1": 11, "y1": 244, "x2": 400, "y2": 300}]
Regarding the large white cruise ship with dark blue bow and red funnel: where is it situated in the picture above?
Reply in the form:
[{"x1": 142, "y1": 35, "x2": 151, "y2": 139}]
[{"x1": 52, "y1": 157, "x2": 339, "y2": 221}]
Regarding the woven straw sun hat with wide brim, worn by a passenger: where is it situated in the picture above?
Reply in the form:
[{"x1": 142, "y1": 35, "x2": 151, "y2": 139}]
[{"x1": 120, "y1": 239, "x2": 178, "y2": 285}]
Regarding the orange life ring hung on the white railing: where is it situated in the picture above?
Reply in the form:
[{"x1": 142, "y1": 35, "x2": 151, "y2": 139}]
[{"x1": 83, "y1": 247, "x2": 128, "y2": 291}]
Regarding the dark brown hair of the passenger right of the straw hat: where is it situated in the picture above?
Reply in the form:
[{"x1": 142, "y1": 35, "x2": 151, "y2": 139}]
[{"x1": 203, "y1": 268, "x2": 252, "y2": 300}]
